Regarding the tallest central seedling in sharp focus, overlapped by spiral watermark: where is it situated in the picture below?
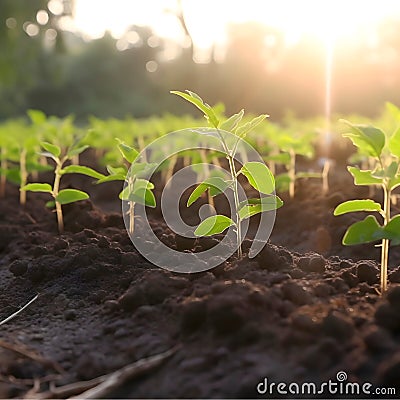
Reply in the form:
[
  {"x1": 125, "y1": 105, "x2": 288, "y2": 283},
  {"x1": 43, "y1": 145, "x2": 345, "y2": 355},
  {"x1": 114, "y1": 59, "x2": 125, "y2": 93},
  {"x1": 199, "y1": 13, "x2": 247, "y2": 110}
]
[{"x1": 171, "y1": 91, "x2": 283, "y2": 258}]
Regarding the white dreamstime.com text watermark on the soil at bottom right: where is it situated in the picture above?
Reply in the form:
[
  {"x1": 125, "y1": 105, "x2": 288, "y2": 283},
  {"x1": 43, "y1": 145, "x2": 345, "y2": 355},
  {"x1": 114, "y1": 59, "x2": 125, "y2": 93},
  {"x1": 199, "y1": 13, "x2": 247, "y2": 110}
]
[{"x1": 257, "y1": 371, "x2": 396, "y2": 398}]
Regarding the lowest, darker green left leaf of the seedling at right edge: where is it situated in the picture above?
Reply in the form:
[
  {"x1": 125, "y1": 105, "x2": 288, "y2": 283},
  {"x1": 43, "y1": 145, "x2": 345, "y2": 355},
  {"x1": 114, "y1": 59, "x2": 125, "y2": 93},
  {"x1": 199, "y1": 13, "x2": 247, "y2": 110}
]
[{"x1": 342, "y1": 215, "x2": 384, "y2": 246}]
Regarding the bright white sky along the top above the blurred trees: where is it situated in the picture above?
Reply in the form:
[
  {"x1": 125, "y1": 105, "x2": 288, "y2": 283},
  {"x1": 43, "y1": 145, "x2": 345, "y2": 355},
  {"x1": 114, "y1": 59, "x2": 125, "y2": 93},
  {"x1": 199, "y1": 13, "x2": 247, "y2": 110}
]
[{"x1": 68, "y1": 0, "x2": 400, "y2": 57}]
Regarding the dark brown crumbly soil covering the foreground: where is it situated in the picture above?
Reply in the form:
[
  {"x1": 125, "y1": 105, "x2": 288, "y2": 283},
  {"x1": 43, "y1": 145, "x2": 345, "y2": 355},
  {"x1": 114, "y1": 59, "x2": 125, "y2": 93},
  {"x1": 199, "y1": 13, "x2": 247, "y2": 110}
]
[{"x1": 0, "y1": 155, "x2": 400, "y2": 398}]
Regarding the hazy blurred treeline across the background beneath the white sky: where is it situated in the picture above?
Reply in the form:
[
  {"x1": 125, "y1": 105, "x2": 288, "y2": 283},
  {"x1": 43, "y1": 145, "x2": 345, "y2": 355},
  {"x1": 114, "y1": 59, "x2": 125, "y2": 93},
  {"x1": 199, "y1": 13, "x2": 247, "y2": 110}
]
[{"x1": 0, "y1": 0, "x2": 400, "y2": 121}]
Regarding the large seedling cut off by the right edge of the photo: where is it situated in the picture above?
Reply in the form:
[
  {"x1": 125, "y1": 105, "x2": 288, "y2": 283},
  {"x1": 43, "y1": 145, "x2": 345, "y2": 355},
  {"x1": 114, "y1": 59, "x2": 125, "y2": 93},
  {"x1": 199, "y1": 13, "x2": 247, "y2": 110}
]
[{"x1": 334, "y1": 117, "x2": 400, "y2": 293}]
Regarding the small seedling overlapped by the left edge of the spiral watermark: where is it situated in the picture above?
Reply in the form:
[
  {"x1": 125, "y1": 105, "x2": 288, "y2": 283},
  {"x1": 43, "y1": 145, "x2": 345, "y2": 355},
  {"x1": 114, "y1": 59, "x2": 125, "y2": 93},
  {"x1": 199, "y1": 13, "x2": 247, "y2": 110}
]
[{"x1": 97, "y1": 139, "x2": 156, "y2": 235}]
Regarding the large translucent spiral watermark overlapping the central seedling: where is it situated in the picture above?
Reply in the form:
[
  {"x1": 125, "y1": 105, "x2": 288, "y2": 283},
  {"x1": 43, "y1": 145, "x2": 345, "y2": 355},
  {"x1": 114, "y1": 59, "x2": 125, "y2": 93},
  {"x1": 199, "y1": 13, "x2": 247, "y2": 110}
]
[{"x1": 122, "y1": 128, "x2": 281, "y2": 273}]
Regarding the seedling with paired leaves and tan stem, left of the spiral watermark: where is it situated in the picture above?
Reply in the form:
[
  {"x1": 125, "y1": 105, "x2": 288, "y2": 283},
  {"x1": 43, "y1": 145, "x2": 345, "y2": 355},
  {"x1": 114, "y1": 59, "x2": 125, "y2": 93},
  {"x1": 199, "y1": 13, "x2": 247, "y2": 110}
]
[{"x1": 20, "y1": 141, "x2": 104, "y2": 233}]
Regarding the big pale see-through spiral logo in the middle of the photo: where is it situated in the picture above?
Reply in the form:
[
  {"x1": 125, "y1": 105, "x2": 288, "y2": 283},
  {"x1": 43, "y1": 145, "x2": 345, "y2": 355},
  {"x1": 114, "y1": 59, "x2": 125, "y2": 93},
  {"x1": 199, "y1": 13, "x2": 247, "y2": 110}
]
[{"x1": 122, "y1": 128, "x2": 276, "y2": 273}]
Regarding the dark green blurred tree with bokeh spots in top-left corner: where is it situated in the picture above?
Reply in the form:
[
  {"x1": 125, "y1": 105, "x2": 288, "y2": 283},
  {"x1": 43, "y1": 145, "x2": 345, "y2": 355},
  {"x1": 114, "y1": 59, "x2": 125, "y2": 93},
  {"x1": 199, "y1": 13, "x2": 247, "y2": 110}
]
[{"x1": 0, "y1": 0, "x2": 70, "y2": 118}]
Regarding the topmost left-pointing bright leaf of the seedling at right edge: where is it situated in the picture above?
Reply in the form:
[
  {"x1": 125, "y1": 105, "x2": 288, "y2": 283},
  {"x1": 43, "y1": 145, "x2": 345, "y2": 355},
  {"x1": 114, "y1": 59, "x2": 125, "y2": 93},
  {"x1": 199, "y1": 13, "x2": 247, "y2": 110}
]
[{"x1": 341, "y1": 120, "x2": 385, "y2": 158}]
